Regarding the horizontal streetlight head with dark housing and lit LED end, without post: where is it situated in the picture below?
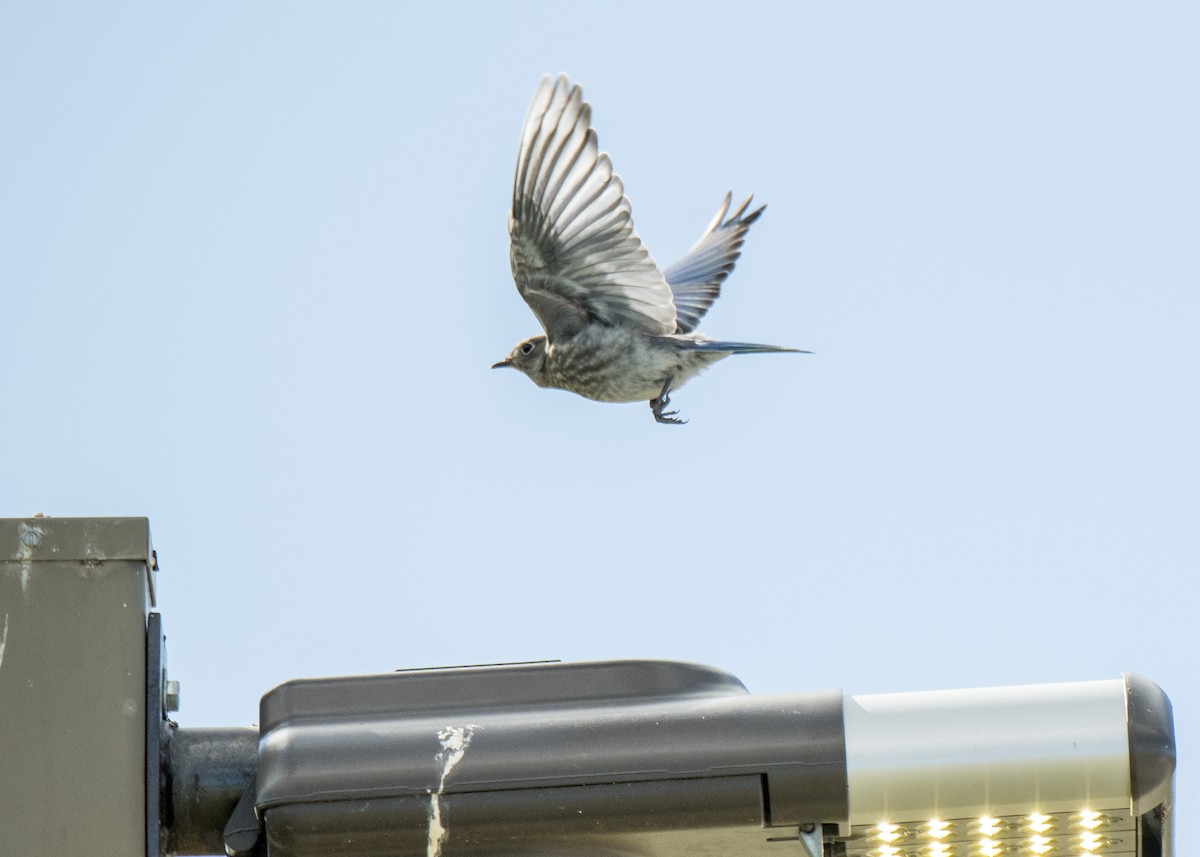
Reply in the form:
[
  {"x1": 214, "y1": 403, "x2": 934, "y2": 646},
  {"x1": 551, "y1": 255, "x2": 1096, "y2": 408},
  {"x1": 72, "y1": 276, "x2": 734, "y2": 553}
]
[{"x1": 256, "y1": 661, "x2": 1175, "y2": 857}]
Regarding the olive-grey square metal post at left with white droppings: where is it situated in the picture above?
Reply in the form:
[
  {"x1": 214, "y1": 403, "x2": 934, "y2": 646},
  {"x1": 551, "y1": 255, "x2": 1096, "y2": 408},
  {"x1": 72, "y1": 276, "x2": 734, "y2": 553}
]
[{"x1": 0, "y1": 517, "x2": 154, "y2": 857}]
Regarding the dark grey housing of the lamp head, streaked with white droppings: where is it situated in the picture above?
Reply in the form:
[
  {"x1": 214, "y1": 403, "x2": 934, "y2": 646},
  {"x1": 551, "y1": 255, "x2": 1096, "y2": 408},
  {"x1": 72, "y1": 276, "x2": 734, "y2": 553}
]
[{"x1": 257, "y1": 661, "x2": 848, "y2": 857}]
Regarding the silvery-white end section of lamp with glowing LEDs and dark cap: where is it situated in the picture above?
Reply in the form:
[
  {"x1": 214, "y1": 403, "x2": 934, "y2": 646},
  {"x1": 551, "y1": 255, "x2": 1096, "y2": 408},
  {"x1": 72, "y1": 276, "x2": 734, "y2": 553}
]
[{"x1": 844, "y1": 675, "x2": 1175, "y2": 857}]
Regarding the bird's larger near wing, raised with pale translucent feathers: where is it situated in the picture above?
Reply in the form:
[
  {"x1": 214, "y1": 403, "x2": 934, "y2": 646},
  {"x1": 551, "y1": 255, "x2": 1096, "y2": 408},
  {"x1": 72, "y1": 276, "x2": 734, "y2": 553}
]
[{"x1": 509, "y1": 76, "x2": 676, "y2": 342}]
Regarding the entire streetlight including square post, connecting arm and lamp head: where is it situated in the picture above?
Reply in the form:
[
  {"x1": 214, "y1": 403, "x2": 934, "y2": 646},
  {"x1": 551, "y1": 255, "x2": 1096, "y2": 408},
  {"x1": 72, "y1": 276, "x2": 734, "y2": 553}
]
[{"x1": 0, "y1": 517, "x2": 1175, "y2": 857}]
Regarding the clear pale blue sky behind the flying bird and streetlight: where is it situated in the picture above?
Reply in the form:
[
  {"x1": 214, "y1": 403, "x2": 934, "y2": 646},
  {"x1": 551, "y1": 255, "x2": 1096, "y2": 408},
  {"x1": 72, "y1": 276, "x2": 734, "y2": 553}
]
[{"x1": 0, "y1": 2, "x2": 1200, "y2": 853}]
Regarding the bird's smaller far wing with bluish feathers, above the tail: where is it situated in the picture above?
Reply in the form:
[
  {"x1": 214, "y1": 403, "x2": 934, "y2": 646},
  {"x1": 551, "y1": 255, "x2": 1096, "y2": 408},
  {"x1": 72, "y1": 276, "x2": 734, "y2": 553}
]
[{"x1": 664, "y1": 193, "x2": 767, "y2": 334}]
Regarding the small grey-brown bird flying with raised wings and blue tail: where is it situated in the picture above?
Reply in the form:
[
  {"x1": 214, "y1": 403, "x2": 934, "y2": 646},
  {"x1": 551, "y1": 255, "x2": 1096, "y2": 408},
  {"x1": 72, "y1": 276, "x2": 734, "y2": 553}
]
[{"x1": 492, "y1": 76, "x2": 799, "y2": 424}]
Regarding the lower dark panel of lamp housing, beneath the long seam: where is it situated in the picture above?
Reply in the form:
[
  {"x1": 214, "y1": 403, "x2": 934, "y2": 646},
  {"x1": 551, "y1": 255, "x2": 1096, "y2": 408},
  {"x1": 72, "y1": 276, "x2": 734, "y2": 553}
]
[{"x1": 265, "y1": 777, "x2": 777, "y2": 857}]
